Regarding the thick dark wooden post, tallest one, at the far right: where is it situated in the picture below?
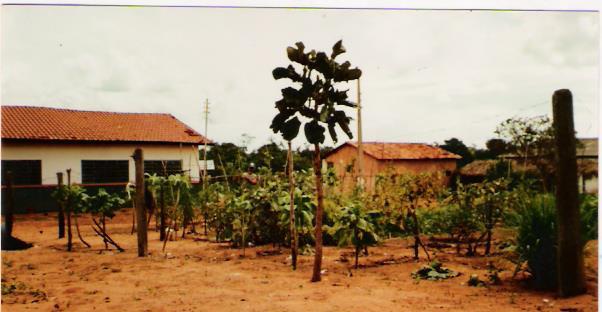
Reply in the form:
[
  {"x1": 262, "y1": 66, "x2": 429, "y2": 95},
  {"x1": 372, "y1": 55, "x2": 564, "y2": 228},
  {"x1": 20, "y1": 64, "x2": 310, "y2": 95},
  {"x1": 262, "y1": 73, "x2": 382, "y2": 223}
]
[{"x1": 552, "y1": 89, "x2": 585, "y2": 297}]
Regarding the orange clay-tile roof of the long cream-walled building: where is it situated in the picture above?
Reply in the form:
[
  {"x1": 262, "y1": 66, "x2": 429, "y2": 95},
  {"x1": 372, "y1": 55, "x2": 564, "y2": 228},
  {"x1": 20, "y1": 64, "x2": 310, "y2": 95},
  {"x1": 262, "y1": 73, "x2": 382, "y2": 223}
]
[{"x1": 2, "y1": 106, "x2": 211, "y2": 144}]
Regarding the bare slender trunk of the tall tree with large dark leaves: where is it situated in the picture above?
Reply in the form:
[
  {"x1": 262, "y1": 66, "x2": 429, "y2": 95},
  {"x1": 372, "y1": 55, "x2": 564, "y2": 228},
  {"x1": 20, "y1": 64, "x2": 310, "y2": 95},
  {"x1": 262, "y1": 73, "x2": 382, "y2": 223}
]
[{"x1": 311, "y1": 143, "x2": 324, "y2": 282}]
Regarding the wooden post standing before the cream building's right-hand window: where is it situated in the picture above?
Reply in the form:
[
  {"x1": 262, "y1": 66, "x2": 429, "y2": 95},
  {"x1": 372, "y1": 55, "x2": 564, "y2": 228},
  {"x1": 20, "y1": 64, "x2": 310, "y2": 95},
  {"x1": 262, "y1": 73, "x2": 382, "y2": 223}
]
[{"x1": 133, "y1": 148, "x2": 148, "y2": 257}]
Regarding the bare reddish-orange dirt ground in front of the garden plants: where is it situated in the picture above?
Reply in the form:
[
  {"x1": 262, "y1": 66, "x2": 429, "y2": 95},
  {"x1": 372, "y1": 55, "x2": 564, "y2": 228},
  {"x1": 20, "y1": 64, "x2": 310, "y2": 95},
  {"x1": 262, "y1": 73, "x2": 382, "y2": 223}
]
[{"x1": 2, "y1": 210, "x2": 598, "y2": 312}]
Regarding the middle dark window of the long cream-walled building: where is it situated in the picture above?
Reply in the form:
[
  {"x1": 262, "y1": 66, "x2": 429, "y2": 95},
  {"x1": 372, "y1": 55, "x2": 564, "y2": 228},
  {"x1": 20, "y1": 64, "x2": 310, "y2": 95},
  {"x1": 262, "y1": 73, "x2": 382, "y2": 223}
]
[{"x1": 82, "y1": 160, "x2": 129, "y2": 184}]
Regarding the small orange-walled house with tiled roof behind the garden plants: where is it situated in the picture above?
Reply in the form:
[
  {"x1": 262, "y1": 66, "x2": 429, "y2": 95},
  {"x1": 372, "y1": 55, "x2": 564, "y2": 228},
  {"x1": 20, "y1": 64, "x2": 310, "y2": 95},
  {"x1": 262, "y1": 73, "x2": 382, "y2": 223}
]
[{"x1": 325, "y1": 142, "x2": 461, "y2": 189}]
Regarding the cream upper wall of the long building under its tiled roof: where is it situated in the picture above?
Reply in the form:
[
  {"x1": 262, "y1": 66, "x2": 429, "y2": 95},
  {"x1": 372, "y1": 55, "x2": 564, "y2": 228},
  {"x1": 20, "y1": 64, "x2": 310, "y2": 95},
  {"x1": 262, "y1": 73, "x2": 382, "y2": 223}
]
[{"x1": 1, "y1": 142, "x2": 199, "y2": 184}]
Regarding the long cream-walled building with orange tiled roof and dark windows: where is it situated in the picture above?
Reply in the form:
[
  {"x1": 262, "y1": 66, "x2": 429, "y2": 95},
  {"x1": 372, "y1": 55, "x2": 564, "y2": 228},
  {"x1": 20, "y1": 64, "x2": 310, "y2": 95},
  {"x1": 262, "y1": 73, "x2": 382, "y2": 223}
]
[{"x1": 2, "y1": 106, "x2": 209, "y2": 212}]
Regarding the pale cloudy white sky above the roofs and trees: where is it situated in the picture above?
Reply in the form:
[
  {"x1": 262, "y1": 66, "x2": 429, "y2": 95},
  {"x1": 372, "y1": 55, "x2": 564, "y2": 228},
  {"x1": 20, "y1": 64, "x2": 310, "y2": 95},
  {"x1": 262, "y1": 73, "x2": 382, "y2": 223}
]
[{"x1": 0, "y1": 6, "x2": 600, "y2": 148}]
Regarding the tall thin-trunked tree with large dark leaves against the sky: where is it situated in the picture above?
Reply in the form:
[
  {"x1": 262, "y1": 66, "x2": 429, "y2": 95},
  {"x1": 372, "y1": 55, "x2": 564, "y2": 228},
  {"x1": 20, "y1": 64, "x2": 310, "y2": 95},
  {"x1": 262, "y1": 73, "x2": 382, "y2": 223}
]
[{"x1": 270, "y1": 40, "x2": 362, "y2": 282}]
